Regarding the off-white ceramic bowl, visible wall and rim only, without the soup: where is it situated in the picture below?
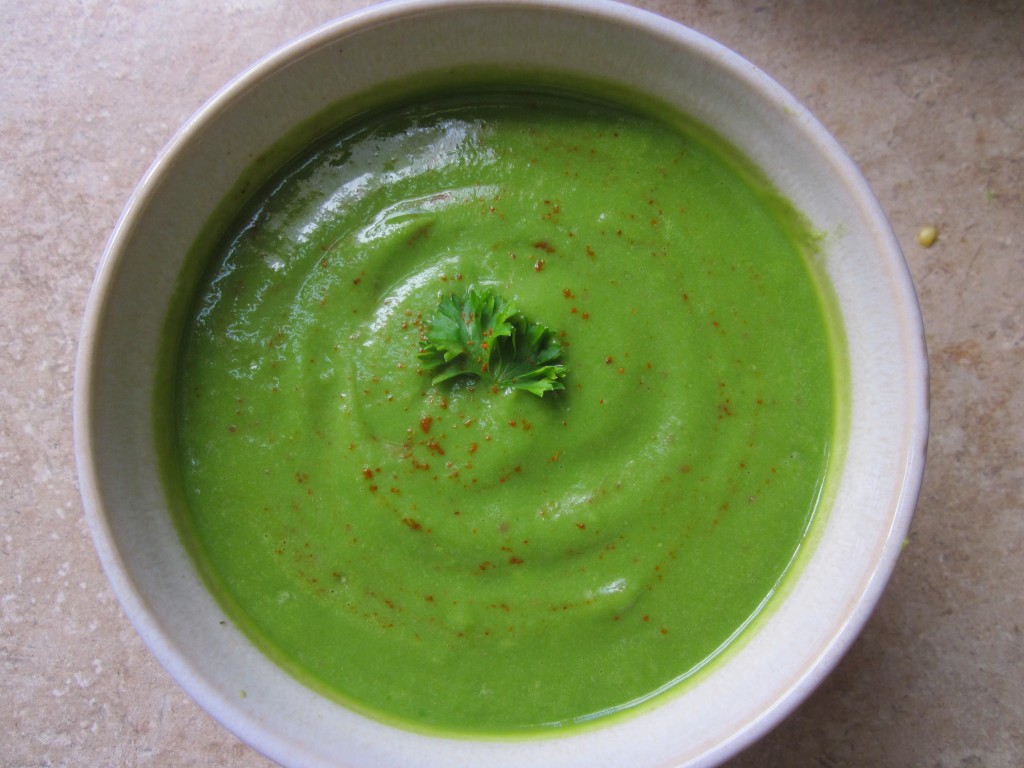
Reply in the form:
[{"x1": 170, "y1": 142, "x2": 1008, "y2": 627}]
[{"x1": 75, "y1": 0, "x2": 928, "y2": 768}]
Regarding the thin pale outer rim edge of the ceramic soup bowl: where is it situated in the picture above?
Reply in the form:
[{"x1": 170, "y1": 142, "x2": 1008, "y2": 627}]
[{"x1": 74, "y1": 0, "x2": 929, "y2": 765}]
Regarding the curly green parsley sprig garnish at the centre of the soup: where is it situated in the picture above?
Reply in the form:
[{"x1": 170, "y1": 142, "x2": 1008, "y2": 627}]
[{"x1": 419, "y1": 288, "x2": 566, "y2": 397}]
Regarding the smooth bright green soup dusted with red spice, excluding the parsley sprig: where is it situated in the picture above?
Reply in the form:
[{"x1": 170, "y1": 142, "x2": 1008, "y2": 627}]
[{"x1": 165, "y1": 87, "x2": 840, "y2": 734}]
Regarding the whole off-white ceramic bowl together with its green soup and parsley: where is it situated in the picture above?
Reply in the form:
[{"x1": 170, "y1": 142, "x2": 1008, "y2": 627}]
[{"x1": 75, "y1": 0, "x2": 928, "y2": 767}]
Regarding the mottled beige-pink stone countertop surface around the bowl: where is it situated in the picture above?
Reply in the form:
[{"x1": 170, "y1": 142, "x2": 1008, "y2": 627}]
[{"x1": 0, "y1": 0, "x2": 1024, "y2": 768}]
